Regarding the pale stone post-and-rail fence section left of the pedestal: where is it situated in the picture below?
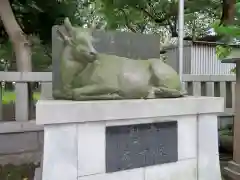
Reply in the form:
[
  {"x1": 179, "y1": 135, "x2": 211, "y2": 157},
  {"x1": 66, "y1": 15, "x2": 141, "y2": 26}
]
[{"x1": 0, "y1": 72, "x2": 52, "y2": 134}]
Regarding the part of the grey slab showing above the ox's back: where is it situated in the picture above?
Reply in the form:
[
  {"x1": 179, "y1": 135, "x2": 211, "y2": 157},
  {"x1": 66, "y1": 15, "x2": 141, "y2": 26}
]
[{"x1": 93, "y1": 30, "x2": 160, "y2": 59}]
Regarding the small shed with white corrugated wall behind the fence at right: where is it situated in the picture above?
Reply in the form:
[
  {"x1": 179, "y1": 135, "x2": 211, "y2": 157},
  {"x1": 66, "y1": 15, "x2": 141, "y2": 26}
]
[{"x1": 163, "y1": 41, "x2": 236, "y2": 75}]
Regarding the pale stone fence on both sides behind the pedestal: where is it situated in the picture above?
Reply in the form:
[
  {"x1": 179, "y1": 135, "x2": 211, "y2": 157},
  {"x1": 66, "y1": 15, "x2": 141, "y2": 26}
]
[{"x1": 0, "y1": 72, "x2": 236, "y2": 133}]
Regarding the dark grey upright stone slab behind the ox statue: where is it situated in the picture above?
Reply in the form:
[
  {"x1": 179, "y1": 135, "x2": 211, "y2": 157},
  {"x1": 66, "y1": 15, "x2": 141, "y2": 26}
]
[{"x1": 52, "y1": 26, "x2": 160, "y2": 94}]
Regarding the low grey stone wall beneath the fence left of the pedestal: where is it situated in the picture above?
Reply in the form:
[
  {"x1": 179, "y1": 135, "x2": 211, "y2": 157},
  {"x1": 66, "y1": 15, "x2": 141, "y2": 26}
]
[{"x1": 0, "y1": 131, "x2": 43, "y2": 165}]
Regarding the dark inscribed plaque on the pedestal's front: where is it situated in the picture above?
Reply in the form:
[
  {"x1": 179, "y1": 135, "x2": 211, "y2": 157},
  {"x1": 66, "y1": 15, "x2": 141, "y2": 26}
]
[{"x1": 106, "y1": 121, "x2": 178, "y2": 172}]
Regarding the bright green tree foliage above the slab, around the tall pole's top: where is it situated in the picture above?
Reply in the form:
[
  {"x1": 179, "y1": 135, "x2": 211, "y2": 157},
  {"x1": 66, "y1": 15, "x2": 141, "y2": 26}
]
[{"x1": 97, "y1": 0, "x2": 221, "y2": 37}]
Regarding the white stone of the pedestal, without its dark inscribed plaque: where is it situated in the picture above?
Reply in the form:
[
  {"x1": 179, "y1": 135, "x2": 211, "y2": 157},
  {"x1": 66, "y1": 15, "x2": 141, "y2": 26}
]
[{"x1": 37, "y1": 97, "x2": 224, "y2": 180}]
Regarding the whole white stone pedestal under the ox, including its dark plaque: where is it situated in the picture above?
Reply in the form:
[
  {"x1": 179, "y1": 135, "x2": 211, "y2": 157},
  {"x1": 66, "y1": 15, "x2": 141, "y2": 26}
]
[{"x1": 36, "y1": 97, "x2": 224, "y2": 180}]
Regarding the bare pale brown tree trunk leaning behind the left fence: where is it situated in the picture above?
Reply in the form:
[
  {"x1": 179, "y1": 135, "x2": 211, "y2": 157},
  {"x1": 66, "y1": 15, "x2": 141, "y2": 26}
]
[{"x1": 0, "y1": 0, "x2": 32, "y2": 72}]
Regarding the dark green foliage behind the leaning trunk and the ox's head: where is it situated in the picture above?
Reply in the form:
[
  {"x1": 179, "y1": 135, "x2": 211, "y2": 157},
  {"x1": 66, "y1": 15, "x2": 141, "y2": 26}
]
[{"x1": 0, "y1": 0, "x2": 95, "y2": 71}]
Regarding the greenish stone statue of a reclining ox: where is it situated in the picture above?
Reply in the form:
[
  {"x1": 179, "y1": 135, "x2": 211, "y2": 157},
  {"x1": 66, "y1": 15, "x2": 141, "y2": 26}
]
[{"x1": 53, "y1": 18, "x2": 185, "y2": 101}]
